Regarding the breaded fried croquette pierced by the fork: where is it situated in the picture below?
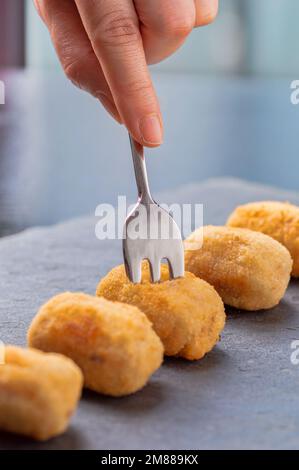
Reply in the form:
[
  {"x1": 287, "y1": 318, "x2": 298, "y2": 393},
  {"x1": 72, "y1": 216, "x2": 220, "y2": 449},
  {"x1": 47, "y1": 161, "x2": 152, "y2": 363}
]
[{"x1": 97, "y1": 262, "x2": 225, "y2": 360}]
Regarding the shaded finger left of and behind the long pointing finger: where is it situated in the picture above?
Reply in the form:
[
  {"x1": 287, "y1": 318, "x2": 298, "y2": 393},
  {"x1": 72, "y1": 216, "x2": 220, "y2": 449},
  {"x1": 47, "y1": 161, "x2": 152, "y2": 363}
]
[{"x1": 34, "y1": 0, "x2": 121, "y2": 122}]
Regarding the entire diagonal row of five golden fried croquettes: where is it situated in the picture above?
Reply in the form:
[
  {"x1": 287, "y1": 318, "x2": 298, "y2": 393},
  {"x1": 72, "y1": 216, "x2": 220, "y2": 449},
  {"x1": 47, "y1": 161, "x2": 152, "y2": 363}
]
[{"x1": 0, "y1": 202, "x2": 299, "y2": 440}]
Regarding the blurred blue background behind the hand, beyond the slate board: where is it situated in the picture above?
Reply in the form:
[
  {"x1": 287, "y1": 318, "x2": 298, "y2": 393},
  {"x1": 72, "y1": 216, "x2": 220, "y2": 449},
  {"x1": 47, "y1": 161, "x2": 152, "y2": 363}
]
[{"x1": 0, "y1": 0, "x2": 299, "y2": 234}]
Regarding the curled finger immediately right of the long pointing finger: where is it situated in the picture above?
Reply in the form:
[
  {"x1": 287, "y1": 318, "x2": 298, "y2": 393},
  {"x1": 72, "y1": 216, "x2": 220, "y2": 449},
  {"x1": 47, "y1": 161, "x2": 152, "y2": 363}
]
[{"x1": 134, "y1": 0, "x2": 195, "y2": 64}]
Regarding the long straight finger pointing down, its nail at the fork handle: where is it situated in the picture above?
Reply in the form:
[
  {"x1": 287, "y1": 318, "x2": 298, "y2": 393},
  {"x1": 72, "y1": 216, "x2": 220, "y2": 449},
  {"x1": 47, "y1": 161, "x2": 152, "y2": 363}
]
[{"x1": 75, "y1": 0, "x2": 163, "y2": 146}]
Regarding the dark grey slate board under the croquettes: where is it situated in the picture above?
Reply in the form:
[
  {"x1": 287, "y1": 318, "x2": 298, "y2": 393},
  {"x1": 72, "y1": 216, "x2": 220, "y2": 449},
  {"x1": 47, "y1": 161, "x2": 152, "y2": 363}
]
[{"x1": 0, "y1": 179, "x2": 299, "y2": 450}]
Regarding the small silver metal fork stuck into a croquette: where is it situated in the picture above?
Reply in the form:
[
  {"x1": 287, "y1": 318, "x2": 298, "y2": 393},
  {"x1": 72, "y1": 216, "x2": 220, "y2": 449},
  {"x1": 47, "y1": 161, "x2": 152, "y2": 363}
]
[{"x1": 123, "y1": 136, "x2": 184, "y2": 283}]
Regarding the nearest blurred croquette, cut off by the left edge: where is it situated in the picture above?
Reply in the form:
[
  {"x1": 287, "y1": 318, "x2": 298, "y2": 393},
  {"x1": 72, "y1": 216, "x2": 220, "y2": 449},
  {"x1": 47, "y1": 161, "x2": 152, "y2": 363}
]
[{"x1": 0, "y1": 346, "x2": 83, "y2": 441}]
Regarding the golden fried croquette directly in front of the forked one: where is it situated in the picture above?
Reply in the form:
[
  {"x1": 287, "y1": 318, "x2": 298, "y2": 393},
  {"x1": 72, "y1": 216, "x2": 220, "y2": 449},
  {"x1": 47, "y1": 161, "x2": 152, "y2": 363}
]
[{"x1": 28, "y1": 292, "x2": 163, "y2": 397}]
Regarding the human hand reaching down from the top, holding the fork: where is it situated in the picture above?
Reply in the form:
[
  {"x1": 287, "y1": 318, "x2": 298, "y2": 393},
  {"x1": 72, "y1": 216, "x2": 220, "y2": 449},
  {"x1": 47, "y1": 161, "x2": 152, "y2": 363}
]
[{"x1": 34, "y1": 0, "x2": 218, "y2": 147}]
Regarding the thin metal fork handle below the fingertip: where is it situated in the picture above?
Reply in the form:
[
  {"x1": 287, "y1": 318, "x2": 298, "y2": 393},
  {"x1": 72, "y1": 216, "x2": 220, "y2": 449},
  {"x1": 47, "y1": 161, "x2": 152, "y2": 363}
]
[{"x1": 129, "y1": 135, "x2": 153, "y2": 204}]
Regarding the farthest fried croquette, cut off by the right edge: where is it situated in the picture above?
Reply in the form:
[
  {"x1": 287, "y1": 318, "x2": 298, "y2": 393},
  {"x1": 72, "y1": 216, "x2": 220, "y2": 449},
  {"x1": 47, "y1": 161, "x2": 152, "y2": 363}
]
[{"x1": 226, "y1": 201, "x2": 299, "y2": 277}]
